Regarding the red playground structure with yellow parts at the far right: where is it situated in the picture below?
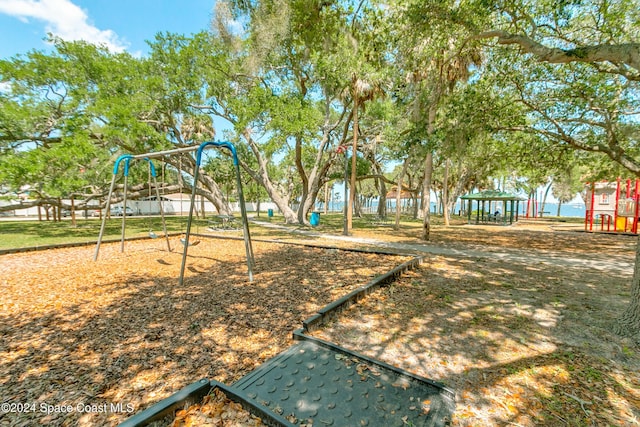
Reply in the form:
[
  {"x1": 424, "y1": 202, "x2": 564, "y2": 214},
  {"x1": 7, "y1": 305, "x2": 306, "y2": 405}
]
[{"x1": 584, "y1": 178, "x2": 640, "y2": 234}]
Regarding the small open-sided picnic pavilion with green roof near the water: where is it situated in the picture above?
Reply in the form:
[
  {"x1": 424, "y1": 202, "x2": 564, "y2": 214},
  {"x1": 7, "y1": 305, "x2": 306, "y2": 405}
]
[{"x1": 461, "y1": 190, "x2": 525, "y2": 225}]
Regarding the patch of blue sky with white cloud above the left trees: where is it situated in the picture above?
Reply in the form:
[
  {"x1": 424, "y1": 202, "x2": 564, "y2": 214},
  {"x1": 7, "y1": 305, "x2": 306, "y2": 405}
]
[{"x1": 0, "y1": 0, "x2": 215, "y2": 59}]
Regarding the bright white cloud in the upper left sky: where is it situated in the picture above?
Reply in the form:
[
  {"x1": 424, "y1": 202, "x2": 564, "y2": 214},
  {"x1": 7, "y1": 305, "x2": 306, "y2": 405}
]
[{"x1": 0, "y1": 0, "x2": 127, "y2": 52}]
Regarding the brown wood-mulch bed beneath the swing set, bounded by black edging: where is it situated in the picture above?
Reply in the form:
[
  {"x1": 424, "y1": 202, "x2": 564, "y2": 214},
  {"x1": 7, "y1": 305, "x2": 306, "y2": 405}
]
[{"x1": 0, "y1": 238, "x2": 407, "y2": 426}]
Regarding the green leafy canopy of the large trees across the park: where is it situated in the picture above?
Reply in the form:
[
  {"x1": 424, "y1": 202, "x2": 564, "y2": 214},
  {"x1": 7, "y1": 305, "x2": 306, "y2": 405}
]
[{"x1": 0, "y1": 0, "x2": 640, "y2": 222}]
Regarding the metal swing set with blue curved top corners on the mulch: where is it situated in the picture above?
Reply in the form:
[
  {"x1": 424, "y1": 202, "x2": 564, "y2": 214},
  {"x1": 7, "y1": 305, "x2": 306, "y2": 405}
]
[{"x1": 93, "y1": 141, "x2": 255, "y2": 285}]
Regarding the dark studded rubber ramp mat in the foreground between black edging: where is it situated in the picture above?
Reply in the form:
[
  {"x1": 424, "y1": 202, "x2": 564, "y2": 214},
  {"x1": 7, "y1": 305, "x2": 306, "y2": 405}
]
[{"x1": 232, "y1": 338, "x2": 455, "y2": 427}]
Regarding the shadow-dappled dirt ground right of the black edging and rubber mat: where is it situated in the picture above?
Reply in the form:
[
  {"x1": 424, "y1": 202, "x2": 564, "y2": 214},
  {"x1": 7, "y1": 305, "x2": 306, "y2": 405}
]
[{"x1": 318, "y1": 252, "x2": 640, "y2": 426}]
